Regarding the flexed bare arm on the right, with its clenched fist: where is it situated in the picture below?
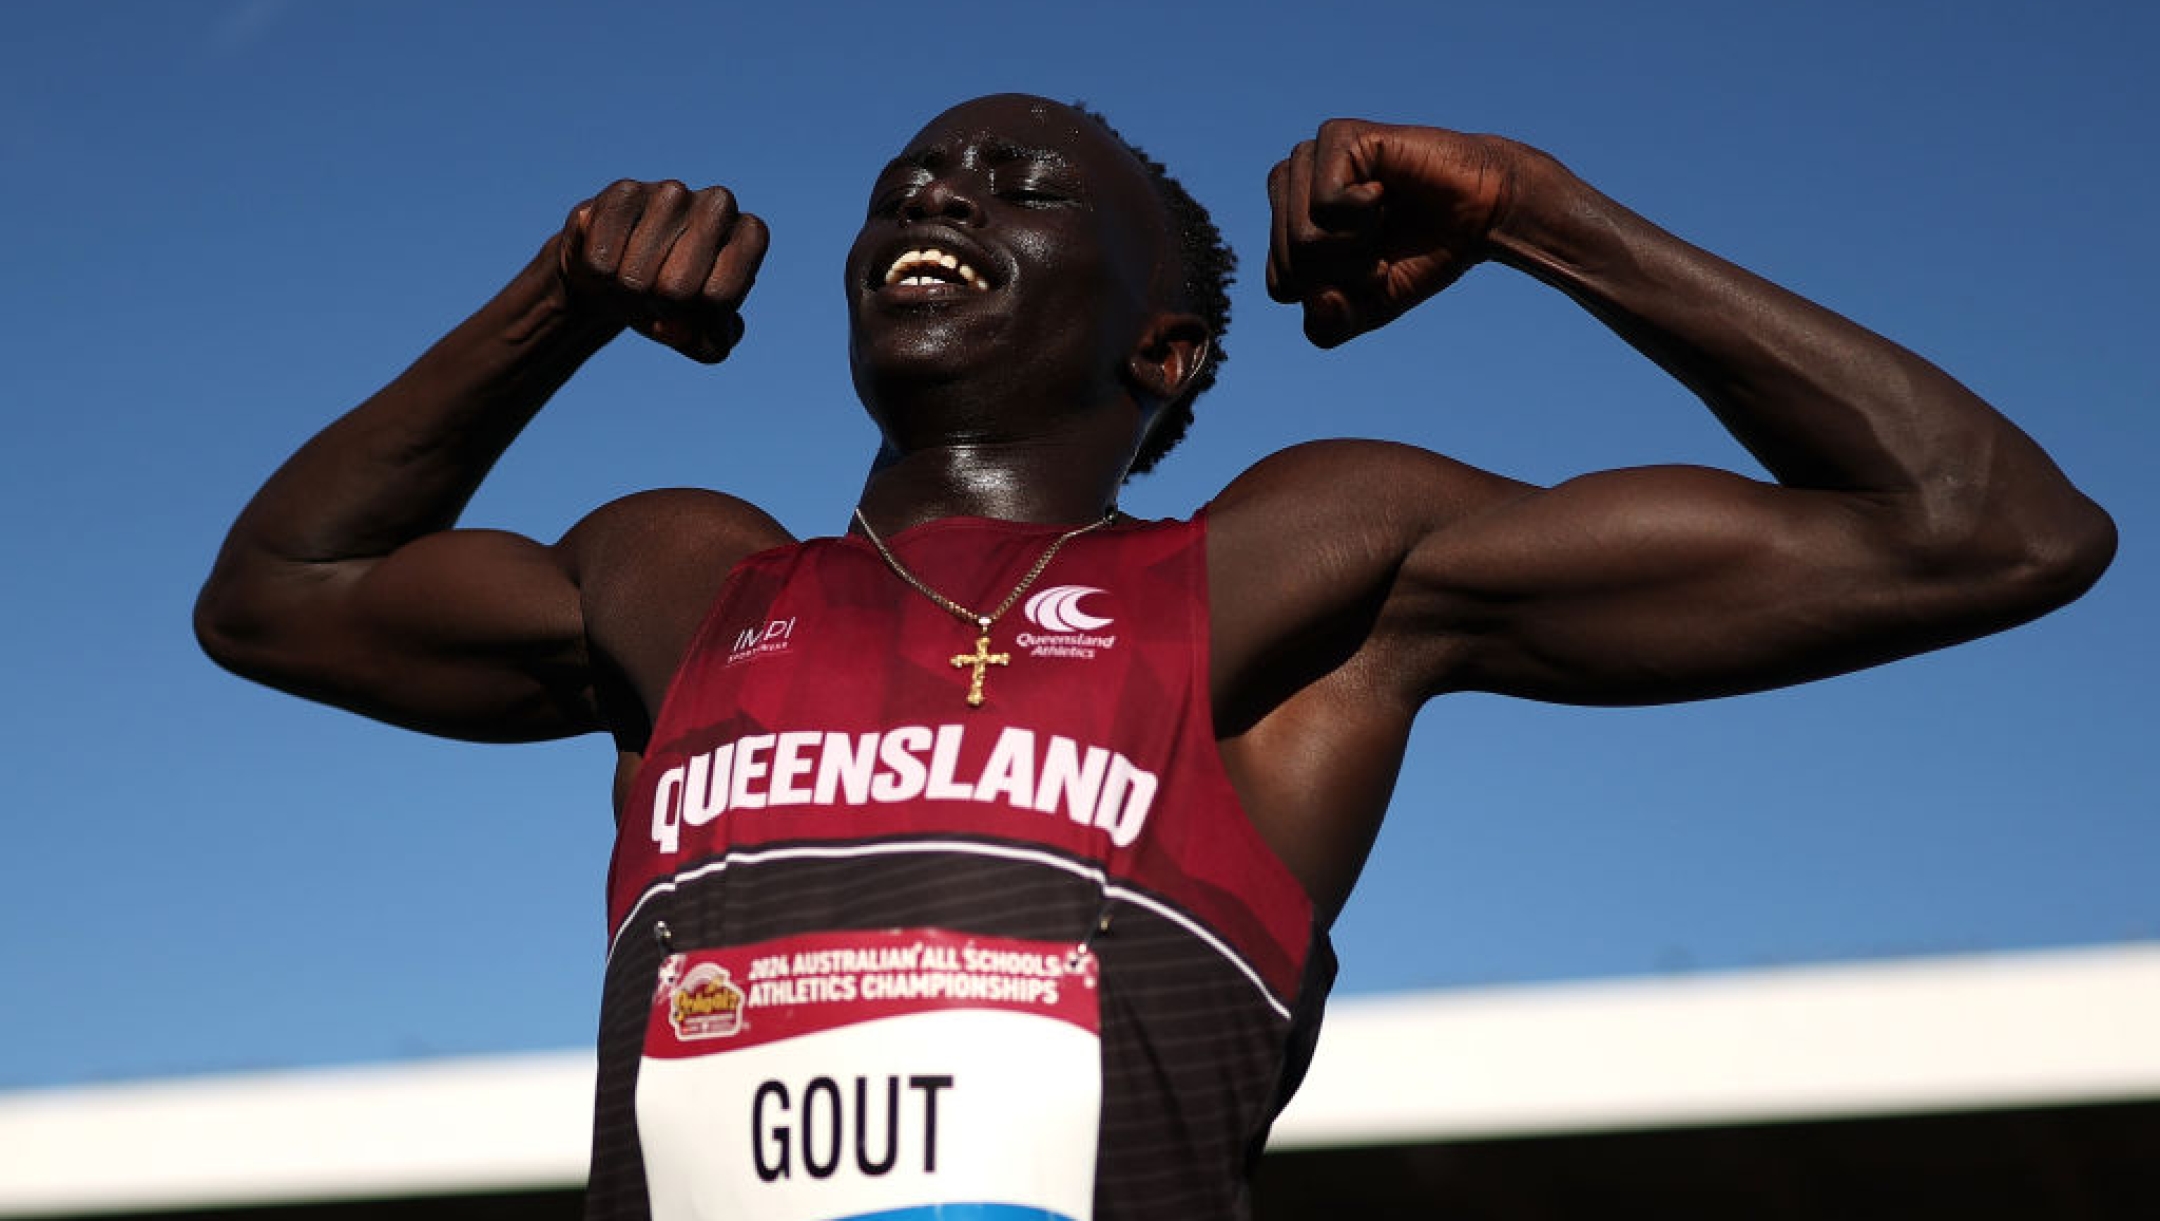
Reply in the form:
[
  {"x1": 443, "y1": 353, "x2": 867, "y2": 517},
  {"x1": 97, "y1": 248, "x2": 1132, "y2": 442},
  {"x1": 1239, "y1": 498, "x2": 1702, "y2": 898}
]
[{"x1": 1251, "y1": 121, "x2": 2115, "y2": 702}]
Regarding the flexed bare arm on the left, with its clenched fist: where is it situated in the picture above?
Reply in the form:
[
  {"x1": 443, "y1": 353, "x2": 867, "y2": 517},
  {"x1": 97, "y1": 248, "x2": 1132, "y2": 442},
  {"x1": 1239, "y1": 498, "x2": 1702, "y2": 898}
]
[{"x1": 194, "y1": 182, "x2": 767, "y2": 741}]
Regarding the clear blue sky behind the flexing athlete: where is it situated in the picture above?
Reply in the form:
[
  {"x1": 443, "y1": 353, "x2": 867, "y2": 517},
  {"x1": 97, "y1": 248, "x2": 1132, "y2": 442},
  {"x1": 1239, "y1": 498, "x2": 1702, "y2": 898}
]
[{"x1": 0, "y1": 0, "x2": 2160, "y2": 1087}]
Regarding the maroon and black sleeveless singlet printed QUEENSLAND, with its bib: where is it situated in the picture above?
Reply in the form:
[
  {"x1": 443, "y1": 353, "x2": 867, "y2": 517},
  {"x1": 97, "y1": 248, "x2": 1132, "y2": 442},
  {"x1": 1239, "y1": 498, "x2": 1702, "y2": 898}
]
[{"x1": 588, "y1": 519, "x2": 1333, "y2": 1221}]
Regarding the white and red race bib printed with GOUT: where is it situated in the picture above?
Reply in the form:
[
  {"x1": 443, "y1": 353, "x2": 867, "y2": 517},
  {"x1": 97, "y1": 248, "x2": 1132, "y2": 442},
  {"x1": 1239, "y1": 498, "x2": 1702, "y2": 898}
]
[{"x1": 637, "y1": 929, "x2": 1102, "y2": 1221}]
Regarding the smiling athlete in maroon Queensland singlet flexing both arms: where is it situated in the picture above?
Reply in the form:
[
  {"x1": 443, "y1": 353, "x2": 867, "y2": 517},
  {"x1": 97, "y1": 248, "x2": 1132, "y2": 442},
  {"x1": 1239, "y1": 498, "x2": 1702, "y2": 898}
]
[{"x1": 199, "y1": 97, "x2": 2112, "y2": 1219}]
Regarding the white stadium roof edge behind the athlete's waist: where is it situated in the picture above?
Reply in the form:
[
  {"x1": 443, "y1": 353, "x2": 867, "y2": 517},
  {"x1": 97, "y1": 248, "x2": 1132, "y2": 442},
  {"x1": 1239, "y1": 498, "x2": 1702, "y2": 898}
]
[{"x1": 0, "y1": 942, "x2": 2160, "y2": 1217}]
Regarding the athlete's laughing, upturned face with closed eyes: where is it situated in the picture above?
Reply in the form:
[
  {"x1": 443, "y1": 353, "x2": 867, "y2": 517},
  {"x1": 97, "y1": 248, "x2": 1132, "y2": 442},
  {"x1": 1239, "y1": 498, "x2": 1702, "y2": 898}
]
[{"x1": 847, "y1": 95, "x2": 1175, "y2": 419}]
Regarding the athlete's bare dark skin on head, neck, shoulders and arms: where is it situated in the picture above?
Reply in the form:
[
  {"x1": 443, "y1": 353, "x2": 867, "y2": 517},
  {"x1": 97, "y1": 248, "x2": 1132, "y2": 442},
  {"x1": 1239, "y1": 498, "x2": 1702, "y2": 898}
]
[{"x1": 197, "y1": 95, "x2": 2115, "y2": 916}]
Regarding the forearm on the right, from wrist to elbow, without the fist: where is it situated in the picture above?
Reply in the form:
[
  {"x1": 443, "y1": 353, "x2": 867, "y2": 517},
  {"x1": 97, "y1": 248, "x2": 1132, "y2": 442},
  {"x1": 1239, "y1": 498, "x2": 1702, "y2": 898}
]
[{"x1": 1493, "y1": 156, "x2": 2104, "y2": 553}]
